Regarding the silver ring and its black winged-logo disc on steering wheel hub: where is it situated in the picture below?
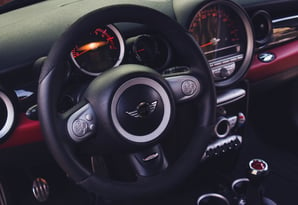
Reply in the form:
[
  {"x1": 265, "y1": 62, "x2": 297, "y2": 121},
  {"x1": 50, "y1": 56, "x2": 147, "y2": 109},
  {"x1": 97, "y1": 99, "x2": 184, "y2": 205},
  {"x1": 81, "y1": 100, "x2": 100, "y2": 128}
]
[{"x1": 111, "y1": 77, "x2": 171, "y2": 142}]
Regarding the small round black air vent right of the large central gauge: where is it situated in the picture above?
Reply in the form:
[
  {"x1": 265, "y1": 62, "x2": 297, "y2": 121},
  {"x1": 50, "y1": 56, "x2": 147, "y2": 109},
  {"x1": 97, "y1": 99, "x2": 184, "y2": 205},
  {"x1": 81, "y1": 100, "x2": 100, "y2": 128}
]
[{"x1": 252, "y1": 10, "x2": 272, "y2": 45}]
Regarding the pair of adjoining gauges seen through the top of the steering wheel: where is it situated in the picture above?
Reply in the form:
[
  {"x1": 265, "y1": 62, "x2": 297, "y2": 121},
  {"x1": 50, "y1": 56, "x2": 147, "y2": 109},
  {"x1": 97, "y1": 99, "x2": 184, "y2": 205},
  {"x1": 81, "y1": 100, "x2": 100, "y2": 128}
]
[{"x1": 70, "y1": 24, "x2": 172, "y2": 76}]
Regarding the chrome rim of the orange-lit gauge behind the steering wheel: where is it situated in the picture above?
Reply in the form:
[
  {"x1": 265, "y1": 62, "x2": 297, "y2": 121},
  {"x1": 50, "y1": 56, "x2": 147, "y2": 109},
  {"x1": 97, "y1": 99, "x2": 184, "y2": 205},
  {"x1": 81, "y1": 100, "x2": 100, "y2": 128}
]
[{"x1": 70, "y1": 24, "x2": 125, "y2": 76}]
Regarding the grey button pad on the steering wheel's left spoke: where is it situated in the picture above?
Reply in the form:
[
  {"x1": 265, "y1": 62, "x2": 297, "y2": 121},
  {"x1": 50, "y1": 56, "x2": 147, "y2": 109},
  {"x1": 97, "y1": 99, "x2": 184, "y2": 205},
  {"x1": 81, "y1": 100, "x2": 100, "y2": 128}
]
[{"x1": 63, "y1": 103, "x2": 96, "y2": 142}]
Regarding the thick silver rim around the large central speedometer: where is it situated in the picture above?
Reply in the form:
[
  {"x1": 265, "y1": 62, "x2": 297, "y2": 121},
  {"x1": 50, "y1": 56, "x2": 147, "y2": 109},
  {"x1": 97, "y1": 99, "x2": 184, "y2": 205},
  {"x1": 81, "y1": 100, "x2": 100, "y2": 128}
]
[{"x1": 187, "y1": 0, "x2": 254, "y2": 87}]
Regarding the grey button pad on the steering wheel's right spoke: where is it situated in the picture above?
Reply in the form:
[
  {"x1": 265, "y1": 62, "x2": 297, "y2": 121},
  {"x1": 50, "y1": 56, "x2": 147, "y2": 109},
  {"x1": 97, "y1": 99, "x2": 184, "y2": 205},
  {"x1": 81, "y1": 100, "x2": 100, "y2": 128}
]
[{"x1": 164, "y1": 72, "x2": 201, "y2": 103}]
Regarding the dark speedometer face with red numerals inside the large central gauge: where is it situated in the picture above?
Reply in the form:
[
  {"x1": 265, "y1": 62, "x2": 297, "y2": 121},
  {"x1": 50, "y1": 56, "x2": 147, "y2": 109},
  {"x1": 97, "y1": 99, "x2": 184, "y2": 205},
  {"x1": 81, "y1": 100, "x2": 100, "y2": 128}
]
[{"x1": 190, "y1": 5, "x2": 246, "y2": 60}]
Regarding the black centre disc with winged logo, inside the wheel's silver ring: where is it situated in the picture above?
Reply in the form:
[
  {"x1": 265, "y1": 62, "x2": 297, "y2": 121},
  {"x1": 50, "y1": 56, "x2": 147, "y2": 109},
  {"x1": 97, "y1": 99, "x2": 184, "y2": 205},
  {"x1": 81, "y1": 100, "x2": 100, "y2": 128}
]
[{"x1": 117, "y1": 85, "x2": 164, "y2": 136}]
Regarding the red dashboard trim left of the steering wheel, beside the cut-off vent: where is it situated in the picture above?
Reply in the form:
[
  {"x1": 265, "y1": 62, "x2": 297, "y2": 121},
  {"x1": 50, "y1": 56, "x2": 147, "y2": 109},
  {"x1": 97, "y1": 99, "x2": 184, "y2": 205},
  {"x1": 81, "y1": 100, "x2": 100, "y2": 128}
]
[{"x1": 0, "y1": 115, "x2": 43, "y2": 149}]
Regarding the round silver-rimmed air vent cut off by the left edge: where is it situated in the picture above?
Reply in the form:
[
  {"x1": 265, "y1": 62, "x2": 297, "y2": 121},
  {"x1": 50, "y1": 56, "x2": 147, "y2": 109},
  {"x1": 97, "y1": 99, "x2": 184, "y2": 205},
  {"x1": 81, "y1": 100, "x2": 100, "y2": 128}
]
[{"x1": 0, "y1": 87, "x2": 16, "y2": 141}]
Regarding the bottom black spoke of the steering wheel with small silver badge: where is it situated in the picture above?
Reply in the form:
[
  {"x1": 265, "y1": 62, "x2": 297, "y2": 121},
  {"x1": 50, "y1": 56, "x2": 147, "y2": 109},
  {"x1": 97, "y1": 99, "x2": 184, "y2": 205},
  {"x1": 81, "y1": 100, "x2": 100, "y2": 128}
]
[{"x1": 129, "y1": 144, "x2": 168, "y2": 177}]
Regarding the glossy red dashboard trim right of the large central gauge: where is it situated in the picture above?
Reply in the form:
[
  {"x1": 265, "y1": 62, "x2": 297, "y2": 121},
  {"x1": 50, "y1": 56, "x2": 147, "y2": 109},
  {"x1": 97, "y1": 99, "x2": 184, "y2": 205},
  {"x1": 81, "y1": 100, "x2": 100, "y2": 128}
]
[{"x1": 246, "y1": 40, "x2": 298, "y2": 81}]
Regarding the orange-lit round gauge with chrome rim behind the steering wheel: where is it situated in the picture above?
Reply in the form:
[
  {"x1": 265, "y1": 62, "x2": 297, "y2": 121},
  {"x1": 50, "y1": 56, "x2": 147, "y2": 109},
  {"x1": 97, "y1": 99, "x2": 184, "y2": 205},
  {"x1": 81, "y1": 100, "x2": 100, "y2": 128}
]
[{"x1": 71, "y1": 25, "x2": 124, "y2": 76}]
